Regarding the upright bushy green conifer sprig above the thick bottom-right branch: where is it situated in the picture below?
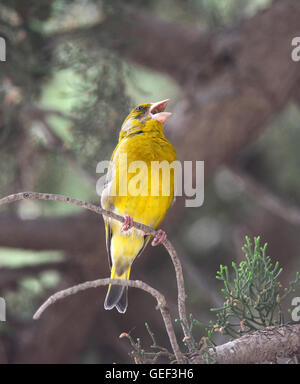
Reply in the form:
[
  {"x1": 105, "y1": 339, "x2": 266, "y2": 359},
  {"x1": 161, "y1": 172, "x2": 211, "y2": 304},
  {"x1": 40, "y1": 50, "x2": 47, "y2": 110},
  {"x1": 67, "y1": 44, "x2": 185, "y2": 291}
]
[{"x1": 209, "y1": 237, "x2": 300, "y2": 337}]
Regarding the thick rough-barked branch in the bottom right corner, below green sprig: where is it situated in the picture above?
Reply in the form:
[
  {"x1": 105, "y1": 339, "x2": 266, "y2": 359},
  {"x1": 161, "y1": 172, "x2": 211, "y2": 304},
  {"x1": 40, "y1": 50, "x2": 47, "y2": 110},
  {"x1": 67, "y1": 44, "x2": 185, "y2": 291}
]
[{"x1": 211, "y1": 324, "x2": 300, "y2": 364}]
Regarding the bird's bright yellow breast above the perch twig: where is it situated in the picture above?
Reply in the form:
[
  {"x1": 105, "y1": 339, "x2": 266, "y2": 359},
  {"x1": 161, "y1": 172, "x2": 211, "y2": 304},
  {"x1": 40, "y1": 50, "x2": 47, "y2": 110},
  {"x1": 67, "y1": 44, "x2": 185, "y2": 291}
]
[{"x1": 102, "y1": 132, "x2": 176, "y2": 228}]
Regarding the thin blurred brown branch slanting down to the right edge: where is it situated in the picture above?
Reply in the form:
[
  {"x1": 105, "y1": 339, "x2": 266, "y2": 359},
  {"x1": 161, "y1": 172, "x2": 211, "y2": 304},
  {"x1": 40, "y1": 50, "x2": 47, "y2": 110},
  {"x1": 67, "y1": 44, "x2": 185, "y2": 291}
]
[{"x1": 228, "y1": 165, "x2": 300, "y2": 225}]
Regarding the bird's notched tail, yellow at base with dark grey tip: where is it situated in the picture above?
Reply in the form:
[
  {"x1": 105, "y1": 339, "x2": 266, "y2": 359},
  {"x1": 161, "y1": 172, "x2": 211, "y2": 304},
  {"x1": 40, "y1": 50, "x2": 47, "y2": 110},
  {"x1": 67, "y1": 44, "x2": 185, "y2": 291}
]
[{"x1": 104, "y1": 266, "x2": 130, "y2": 313}]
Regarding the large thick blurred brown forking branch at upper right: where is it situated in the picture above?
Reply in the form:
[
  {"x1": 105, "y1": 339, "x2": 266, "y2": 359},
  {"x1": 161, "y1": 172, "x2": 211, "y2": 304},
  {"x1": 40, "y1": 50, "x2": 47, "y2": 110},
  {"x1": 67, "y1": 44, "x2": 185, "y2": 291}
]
[{"x1": 7, "y1": 0, "x2": 300, "y2": 184}]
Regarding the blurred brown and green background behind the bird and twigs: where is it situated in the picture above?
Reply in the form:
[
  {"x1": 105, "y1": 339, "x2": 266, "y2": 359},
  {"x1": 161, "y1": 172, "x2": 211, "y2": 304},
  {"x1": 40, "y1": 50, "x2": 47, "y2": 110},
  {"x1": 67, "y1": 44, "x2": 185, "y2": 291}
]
[{"x1": 0, "y1": 0, "x2": 300, "y2": 363}]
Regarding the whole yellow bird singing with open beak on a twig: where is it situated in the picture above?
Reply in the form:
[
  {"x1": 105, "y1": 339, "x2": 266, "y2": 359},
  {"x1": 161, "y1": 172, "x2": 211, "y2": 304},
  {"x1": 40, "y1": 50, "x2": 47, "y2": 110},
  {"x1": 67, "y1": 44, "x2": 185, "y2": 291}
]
[{"x1": 101, "y1": 100, "x2": 176, "y2": 313}]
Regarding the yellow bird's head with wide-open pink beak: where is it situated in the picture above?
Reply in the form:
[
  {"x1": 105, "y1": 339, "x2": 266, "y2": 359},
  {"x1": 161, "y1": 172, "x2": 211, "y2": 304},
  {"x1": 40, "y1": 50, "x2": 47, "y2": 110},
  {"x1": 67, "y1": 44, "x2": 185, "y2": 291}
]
[{"x1": 120, "y1": 99, "x2": 171, "y2": 139}]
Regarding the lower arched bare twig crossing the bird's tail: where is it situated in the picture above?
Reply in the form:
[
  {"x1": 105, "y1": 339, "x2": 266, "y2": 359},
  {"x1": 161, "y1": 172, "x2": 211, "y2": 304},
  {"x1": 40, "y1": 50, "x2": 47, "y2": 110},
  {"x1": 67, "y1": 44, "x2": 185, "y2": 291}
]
[{"x1": 33, "y1": 279, "x2": 184, "y2": 364}]
